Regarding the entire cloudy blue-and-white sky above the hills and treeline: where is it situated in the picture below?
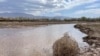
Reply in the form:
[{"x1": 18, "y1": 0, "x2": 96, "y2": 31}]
[{"x1": 0, "y1": 0, "x2": 100, "y2": 17}]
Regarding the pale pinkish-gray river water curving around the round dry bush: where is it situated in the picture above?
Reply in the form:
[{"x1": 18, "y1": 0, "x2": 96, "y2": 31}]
[{"x1": 0, "y1": 24, "x2": 85, "y2": 56}]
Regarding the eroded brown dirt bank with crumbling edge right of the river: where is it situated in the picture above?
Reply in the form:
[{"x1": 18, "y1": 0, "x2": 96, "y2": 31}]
[{"x1": 74, "y1": 24, "x2": 100, "y2": 56}]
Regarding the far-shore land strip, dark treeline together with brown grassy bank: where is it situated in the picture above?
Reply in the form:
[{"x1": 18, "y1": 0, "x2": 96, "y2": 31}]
[{"x1": 0, "y1": 17, "x2": 100, "y2": 27}]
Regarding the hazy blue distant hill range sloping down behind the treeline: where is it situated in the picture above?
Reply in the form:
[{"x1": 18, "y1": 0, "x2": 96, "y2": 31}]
[{"x1": 0, "y1": 13, "x2": 70, "y2": 20}]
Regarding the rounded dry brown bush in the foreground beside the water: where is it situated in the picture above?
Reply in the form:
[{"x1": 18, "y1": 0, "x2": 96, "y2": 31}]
[{"x1": 53, "y1": 35, "x2": 79, "y2": 56}]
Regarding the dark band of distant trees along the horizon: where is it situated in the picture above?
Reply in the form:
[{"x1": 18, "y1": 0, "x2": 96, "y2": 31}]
[{"x1": 0, "y1": 17, "x2": 100, "y2": 22}]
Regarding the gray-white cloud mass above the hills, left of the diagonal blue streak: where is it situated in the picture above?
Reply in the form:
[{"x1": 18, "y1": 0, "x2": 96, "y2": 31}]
[{"x1": 0, "y1": 0, "x2": 98, "y2": 15}]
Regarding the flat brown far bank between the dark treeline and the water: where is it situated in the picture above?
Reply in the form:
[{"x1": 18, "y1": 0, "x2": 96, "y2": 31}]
[{"x1": 0, "y1": 21, "x2": 98, "y2": 28}]
